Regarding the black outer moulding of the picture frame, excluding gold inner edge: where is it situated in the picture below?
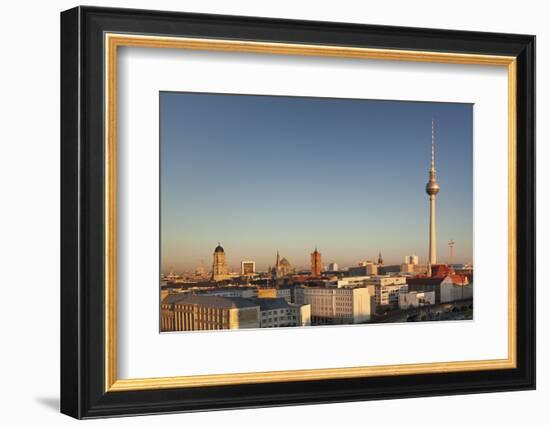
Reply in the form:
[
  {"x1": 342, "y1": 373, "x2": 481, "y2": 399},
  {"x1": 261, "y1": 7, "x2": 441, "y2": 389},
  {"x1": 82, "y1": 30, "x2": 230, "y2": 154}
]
[{"x1": 61, "y1": 6, "x2": 535, "y2": 418}]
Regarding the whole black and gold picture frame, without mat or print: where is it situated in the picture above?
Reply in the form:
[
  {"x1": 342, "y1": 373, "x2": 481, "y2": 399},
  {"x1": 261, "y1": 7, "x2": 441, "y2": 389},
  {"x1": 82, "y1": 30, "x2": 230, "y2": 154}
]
[{"x1": 61, "y1": 7, "x2": 535, "y2": 418}]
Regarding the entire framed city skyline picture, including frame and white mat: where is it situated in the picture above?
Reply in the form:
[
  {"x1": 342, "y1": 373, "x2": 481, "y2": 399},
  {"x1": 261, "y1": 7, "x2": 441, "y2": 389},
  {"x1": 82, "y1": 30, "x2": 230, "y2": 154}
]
[{"x1": 61, "y1": 7, "x2": 535, "y2": 418}]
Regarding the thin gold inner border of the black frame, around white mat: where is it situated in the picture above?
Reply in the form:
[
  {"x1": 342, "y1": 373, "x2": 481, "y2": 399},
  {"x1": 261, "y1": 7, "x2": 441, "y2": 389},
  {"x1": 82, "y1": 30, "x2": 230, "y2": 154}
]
[{"x1": 104, "y1": 33, "x2": 517, "y2": 392}]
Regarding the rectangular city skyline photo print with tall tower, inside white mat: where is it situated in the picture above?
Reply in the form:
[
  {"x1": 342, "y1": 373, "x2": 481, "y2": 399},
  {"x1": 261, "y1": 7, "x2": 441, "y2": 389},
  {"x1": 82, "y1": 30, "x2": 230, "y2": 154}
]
[{"x1": 159, "y1": 92, "x2": 474, "y2": 332}]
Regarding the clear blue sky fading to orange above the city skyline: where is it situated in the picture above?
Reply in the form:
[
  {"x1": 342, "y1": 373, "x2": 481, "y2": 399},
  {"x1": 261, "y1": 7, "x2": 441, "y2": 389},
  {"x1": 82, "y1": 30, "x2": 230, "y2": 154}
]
[{"x1": 160, "y1": 92, "x2": 473, "y2": 271}]
